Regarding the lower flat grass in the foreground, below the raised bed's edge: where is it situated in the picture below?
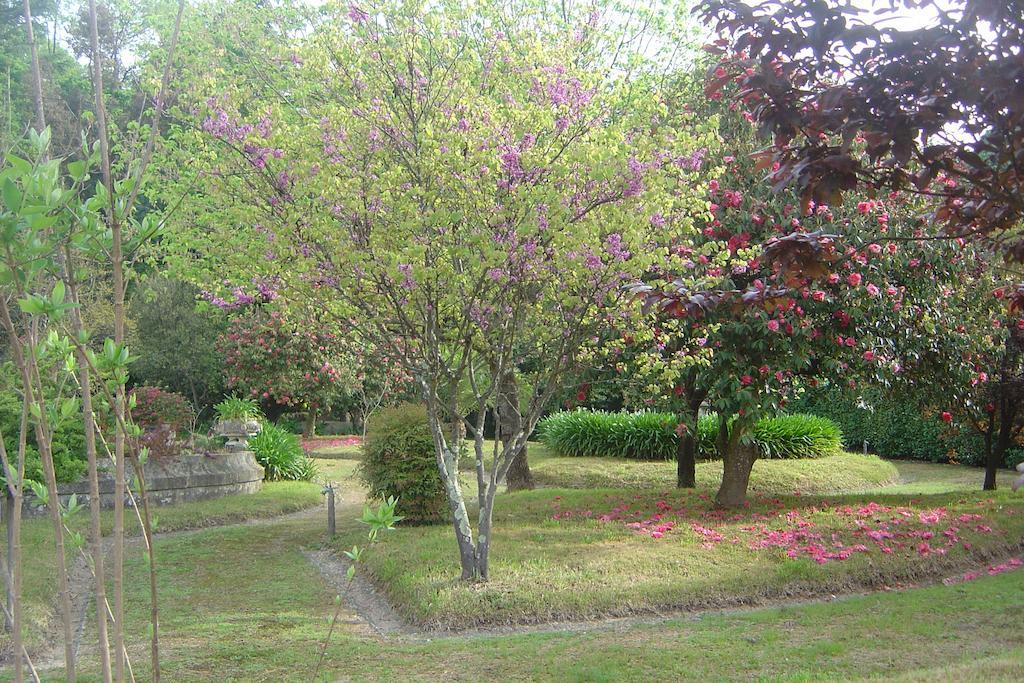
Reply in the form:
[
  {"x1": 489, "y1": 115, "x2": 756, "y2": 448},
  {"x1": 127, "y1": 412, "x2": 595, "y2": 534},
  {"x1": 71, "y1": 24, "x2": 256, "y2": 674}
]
[{"x1": 36, "y1": 511, "x2": 1024, "y2": 682}]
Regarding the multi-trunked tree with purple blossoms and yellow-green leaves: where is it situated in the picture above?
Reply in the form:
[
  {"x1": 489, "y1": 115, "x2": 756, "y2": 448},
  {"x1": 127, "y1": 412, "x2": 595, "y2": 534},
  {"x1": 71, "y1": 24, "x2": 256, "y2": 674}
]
[{"x1": 157, "y1": 2, "x2": 707, "y2": 580}]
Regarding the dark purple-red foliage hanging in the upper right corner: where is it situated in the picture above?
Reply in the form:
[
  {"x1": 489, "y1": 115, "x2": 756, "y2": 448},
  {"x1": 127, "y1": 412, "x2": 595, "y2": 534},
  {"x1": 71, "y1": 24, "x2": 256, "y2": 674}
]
[{"x1": 698, "y1": 0, "x2": 1024, "y2": 260}]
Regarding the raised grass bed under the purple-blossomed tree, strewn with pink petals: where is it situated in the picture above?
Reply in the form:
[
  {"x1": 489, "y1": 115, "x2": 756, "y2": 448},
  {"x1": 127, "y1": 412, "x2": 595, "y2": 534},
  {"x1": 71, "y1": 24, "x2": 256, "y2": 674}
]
[{"x1": 346, "y1": 489, "x2": 1024, "y2": 628}]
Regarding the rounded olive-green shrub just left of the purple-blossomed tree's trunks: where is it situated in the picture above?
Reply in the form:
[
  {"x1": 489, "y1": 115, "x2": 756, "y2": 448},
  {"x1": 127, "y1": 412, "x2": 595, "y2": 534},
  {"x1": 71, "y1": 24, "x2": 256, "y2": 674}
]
[{"x1": 358, "y1": 403, "x2": 447, "y2": 523}]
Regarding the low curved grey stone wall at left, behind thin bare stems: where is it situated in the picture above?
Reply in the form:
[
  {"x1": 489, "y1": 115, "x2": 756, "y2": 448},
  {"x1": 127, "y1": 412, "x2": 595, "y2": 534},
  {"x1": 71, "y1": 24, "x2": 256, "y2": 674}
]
[{"x1": 25, "y1": 451, "x2": 263, "y2": 512}]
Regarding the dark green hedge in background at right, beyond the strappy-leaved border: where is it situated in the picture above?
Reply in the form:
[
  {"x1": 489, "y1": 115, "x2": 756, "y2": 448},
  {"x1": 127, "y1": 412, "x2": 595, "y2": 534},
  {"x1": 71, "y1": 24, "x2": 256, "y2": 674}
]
[{"x1": 791, "y1": 387, "x2": 1024, "y2": 467}]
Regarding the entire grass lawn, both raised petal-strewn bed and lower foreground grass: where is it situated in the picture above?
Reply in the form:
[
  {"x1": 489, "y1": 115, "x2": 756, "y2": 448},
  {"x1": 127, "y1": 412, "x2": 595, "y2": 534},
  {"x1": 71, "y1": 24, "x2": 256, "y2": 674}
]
[{"x1": 8, "y1": 446, "x2": 1024, "y2": 681}]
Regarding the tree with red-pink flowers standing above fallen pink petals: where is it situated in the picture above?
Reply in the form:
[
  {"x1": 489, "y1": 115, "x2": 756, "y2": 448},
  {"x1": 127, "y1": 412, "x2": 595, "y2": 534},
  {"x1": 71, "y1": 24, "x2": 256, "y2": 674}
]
[{"x1": 630, "y1": 101, "x2": 976, "y2": 506}]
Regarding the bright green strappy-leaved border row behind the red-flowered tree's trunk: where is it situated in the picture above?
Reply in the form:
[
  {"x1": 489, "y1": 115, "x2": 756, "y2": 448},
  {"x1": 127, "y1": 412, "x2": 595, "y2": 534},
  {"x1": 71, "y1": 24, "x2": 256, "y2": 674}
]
[{"x1": 538, "y1": 410, "x2": 843, "y2": 460}]
